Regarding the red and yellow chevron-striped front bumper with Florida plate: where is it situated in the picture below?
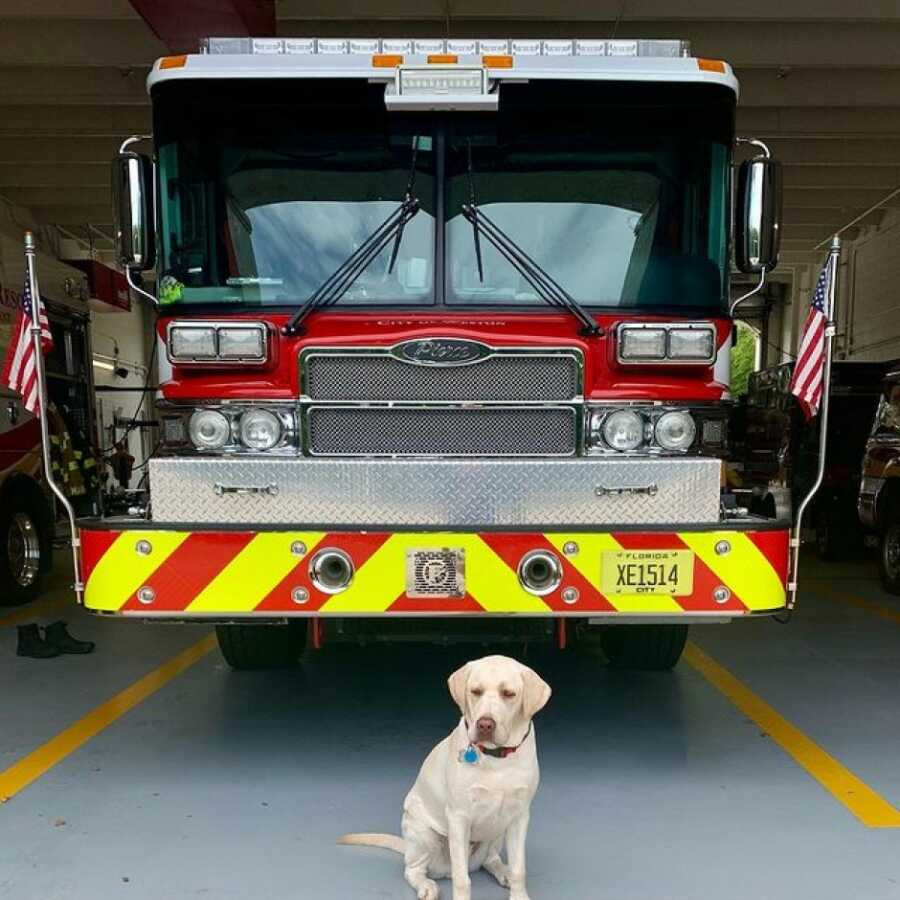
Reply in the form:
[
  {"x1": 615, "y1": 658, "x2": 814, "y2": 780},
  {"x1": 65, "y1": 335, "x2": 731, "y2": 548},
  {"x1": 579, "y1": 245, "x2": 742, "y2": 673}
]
[{"x1": 81, "y1": 526, "x2": 788, "y2": 620}]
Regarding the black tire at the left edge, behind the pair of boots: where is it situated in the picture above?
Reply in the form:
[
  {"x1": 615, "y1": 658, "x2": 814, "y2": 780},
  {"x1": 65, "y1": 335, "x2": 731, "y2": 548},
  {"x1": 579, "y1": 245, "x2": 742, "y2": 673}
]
[{"x1": 0, "y1": 491, "x2": 49, "y2": 606}]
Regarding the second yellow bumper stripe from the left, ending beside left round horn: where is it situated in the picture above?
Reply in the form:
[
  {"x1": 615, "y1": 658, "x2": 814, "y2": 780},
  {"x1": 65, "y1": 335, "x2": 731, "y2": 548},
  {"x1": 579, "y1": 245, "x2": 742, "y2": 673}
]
[{"x1": 187, "y1": 531, "x2": 325, "y2": 613}]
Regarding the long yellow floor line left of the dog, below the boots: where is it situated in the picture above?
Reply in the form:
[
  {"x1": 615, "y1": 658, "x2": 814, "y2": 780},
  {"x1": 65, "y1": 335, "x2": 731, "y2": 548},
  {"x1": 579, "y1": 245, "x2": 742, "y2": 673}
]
[{"x1": 0, "y1": 634, "x2": 216, "y2": 802}]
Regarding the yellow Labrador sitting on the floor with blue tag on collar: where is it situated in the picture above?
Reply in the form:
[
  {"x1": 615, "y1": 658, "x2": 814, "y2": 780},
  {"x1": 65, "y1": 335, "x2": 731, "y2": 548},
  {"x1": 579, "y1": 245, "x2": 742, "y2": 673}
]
[{"x1": 340, "y1": 656, "x2": 550, "y2": 900}]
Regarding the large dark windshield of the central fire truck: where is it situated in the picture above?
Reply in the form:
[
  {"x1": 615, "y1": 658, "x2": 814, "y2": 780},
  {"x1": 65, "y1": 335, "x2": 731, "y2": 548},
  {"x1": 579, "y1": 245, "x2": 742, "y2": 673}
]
[{"x1": 154, "y1": 80, "x2": 734, "y2": 314}]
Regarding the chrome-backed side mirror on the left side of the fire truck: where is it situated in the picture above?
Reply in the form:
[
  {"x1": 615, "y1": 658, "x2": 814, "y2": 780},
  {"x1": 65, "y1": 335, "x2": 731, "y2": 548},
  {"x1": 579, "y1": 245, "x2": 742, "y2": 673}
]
[{"x1": 112, "y1": 150, "x2": 156, "y2": 272}]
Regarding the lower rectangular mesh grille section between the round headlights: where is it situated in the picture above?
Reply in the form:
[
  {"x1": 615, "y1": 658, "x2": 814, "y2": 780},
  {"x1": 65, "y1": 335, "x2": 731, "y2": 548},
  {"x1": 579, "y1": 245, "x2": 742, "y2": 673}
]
[{"x1": 306, "y1": 406, "x2": 578, "y2": 456}]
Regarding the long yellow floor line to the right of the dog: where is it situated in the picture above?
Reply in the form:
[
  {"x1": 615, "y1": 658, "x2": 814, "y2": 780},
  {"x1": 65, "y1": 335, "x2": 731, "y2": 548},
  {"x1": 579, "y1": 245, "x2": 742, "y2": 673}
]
[{"x1": 684, "y1": 643, "x2": 900, "y2": 828}]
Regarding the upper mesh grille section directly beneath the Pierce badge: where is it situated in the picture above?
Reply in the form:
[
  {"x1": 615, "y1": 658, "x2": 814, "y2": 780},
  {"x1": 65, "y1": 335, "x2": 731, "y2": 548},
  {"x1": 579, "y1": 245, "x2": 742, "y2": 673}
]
[{"x1": 302, "y1": 350, "x2": 581, "y2": 403}]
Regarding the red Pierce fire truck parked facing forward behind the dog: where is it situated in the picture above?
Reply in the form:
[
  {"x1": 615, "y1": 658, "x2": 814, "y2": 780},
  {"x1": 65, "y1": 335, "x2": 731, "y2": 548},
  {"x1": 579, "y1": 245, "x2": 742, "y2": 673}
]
[{"x1": 79, "y1": 38, "x2": 789, "y2": 668}]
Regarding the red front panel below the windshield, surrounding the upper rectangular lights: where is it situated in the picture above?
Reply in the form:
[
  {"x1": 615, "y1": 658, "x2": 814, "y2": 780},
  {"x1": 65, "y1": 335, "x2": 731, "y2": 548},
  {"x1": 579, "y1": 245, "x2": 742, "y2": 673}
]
[{"x1": 157, "y1": 308, "x2": 732, "y2": 402}]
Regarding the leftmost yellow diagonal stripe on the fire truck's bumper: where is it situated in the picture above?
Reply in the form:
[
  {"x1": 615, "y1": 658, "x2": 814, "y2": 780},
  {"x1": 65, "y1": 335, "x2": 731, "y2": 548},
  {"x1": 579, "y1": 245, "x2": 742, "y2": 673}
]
[{"x1": 84, "y1": 531, "x2": 189, "y2": 611}]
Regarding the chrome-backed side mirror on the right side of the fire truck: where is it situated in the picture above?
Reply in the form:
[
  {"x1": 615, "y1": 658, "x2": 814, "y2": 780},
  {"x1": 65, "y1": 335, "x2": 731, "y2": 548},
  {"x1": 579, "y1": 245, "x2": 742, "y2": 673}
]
[{"x1": 734, "y1": 156, "x2": 781, "y2": 273}]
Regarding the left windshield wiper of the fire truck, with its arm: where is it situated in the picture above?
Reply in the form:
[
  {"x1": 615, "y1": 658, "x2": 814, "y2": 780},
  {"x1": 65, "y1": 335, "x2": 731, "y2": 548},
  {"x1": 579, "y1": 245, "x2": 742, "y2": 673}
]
[{"x1": 282, "y1": 136, "x2": 419, "y2": 337}]
